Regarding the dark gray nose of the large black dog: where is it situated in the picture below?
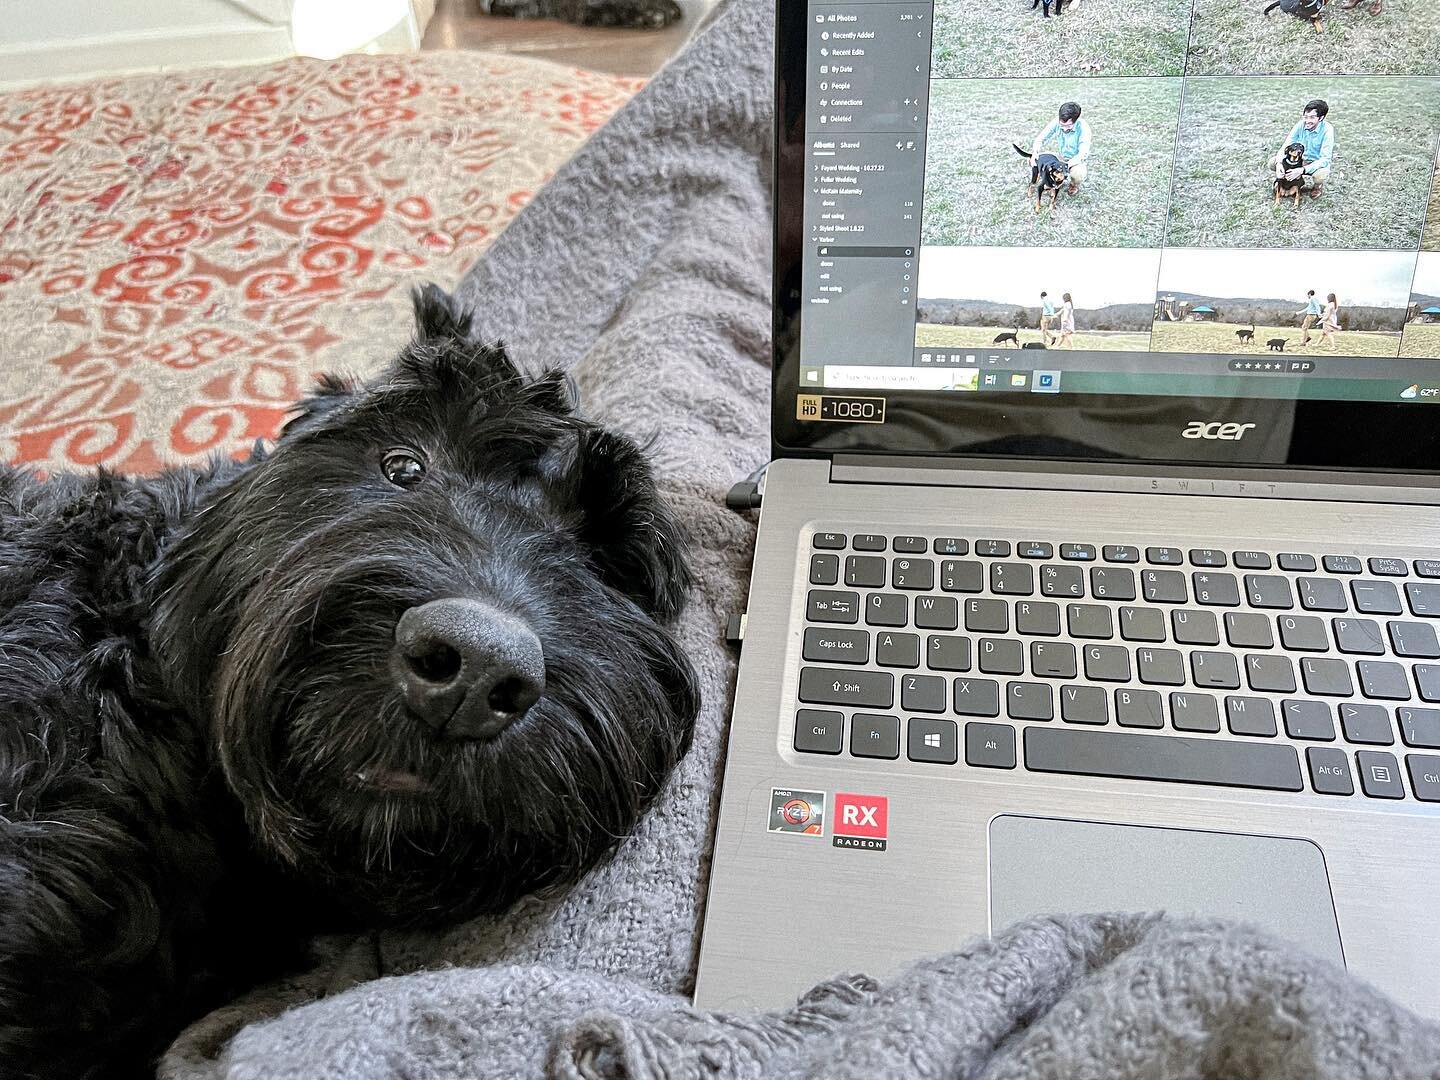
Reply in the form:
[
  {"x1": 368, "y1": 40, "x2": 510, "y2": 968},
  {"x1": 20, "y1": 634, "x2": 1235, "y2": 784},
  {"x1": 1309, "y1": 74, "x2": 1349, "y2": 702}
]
[{"x1": 395, "y1": 596, "x2": 544, "y2": 739}]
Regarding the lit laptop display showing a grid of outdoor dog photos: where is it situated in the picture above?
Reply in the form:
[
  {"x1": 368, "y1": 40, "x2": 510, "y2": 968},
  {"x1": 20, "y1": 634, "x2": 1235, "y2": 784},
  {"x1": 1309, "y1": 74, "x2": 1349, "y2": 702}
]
[{"x1": 799, "y1": 0, "x2": 1440, "y2": 402}]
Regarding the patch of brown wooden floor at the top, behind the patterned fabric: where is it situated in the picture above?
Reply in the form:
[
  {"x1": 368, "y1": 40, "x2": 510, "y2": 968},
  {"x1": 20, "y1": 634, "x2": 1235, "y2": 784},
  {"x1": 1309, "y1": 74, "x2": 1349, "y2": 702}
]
[{"x1": 420, "y1": 0, "x2": 713, "y2": 76}]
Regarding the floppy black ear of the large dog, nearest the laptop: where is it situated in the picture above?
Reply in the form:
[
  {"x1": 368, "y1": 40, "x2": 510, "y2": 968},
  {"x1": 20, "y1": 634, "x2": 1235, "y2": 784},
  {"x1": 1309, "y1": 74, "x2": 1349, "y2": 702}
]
[{"x1": 575, "y1": 428, "x2": 690, "y2": 621}]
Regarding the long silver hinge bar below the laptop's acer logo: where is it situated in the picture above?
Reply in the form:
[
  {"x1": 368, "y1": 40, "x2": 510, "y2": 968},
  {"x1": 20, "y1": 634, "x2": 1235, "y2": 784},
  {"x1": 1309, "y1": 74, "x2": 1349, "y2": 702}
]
[{"x1": 829, "y1": 454, "x2": 1440, "y2": 505}]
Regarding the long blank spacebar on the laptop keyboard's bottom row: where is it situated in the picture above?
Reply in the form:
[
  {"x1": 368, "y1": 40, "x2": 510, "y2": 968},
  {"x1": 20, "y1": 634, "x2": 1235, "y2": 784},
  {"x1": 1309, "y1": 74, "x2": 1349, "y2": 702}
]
[{"x1": 1025, "y1": 727, "x2": 1305, "y2": 791}]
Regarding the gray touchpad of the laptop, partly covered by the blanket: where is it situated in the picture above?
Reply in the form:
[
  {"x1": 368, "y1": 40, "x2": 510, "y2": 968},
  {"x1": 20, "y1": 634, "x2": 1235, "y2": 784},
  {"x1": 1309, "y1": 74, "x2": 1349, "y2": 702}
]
[{"x1": 989, "y1": 815, "x2": 1345, "y2": 963}]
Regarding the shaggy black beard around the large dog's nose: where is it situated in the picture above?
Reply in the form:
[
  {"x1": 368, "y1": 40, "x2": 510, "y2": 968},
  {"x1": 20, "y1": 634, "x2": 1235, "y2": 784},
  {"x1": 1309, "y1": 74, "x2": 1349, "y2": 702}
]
[{"x1": 208, "y1": 556, "x2": 696, "y2": 922}]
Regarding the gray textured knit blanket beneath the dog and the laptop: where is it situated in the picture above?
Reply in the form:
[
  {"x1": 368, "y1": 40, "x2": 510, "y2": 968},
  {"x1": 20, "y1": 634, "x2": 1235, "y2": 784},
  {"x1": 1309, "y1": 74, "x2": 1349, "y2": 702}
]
[{"x1": 161, "y1": 0, "x2": 1440, "y2": 1080}]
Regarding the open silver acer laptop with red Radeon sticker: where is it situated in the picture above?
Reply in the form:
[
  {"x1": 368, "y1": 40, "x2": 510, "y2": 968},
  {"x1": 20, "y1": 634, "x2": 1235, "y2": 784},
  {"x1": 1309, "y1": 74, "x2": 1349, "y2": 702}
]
[{"x1": 696, "y1": 0, "x2": 1440, "y2": 1017}]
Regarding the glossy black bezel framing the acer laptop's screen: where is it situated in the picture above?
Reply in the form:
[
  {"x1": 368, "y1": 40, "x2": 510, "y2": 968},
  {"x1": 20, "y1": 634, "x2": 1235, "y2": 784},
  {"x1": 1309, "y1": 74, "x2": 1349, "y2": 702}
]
[{"x1": 770, "y1": 0, "x2": 1440, "y2": 474}]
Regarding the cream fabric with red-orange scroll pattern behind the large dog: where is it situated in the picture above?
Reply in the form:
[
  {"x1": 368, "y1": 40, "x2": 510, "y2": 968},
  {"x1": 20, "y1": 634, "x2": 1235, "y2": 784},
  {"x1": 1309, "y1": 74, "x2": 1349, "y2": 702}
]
[{"x1": 0, "y1": 52, "x2": 641, "y2": 472}]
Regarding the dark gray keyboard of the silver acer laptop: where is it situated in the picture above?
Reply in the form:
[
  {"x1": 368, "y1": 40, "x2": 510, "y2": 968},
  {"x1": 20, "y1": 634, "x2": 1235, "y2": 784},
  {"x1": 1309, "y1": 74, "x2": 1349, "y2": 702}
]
[{"x1": 793, "y1": 533, "x2": 1440, "y2": 802}]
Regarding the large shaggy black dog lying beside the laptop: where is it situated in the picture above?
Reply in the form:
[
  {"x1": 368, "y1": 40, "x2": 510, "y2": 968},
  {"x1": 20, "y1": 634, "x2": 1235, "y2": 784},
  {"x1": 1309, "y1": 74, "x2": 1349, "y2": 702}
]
[{"x1": 0, "y1": 287, "x2": 698, "y2": 1080}]
